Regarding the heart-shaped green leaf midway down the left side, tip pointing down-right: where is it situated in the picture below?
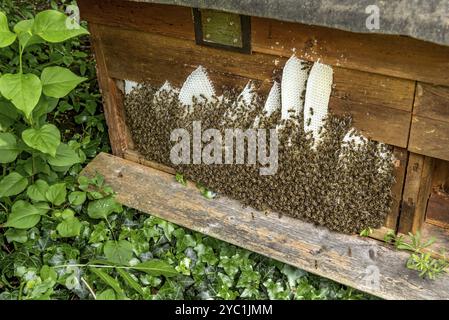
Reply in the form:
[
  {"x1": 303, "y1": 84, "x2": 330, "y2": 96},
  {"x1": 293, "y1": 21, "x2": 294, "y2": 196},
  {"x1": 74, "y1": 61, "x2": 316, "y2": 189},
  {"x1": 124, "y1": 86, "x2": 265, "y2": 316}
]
[{"x1": 22, "y1": 124, "x2": 61, "y2": 157}]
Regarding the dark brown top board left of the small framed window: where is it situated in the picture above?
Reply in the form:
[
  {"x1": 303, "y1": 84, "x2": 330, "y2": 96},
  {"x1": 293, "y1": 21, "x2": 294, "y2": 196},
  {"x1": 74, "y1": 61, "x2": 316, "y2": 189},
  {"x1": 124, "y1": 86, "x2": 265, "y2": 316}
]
[{"x1": 77, "y1": 0, "x2": 195, "y2": 40}]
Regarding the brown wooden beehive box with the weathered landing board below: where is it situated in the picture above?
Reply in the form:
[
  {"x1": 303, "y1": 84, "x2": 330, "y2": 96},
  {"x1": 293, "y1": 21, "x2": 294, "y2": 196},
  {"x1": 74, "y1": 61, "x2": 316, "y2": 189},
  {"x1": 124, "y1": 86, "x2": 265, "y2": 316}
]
[{"x1": 78, "y1": 0, "x2": 449, "y2": 298}]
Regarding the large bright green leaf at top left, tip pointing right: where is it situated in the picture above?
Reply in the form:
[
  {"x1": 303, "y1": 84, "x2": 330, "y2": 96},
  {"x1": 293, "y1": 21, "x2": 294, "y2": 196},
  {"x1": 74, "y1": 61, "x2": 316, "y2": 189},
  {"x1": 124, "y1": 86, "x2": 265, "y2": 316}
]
[{"x1": 32, "y1": 10, "x2": 89, "y2": 42}]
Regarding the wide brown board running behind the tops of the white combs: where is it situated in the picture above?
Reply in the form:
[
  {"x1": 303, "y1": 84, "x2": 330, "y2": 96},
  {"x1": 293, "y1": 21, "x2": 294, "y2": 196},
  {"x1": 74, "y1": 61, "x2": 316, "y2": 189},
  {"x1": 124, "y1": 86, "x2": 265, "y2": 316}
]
[{"x1": 96, "y1": 26, "x2": 414, "y2": 148}]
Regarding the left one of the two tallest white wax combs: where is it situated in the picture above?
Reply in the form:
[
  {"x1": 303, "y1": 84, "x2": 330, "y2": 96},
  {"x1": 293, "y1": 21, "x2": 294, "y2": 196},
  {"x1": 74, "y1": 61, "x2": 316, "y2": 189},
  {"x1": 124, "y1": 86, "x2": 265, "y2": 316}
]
[{"x1": 281, "y1": 55, "x2": 307, "y2": 120}]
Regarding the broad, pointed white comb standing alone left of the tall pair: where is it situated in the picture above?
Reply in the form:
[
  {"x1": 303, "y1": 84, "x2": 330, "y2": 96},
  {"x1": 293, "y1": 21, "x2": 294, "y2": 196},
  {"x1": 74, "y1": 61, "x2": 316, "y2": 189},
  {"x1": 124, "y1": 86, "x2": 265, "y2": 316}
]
[{"x1": 179, "y1": 66, "x2": 215, "y2": 107}]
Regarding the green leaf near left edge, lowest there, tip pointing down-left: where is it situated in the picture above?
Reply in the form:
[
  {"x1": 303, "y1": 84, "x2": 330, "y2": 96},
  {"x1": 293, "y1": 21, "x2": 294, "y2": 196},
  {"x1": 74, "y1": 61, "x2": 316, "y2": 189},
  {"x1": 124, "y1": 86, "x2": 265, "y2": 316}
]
[{"x1": 5, "y1": 200, "x2": 41, "y2": 229}]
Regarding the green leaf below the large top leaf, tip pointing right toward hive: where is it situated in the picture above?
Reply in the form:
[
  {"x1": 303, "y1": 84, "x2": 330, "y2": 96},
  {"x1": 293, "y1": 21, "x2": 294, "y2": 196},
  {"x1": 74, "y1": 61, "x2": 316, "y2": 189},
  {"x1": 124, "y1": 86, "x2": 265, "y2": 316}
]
[{"x1": 41, "y1": 67, "x2": 87, "y2": 98}]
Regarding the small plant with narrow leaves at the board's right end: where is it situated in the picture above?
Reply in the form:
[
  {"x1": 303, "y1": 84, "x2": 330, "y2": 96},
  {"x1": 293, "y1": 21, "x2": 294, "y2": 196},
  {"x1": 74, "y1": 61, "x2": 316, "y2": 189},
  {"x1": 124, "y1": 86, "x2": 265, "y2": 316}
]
[{"x1": 384, "y1": 231, "x2": 449, "y2": 279}]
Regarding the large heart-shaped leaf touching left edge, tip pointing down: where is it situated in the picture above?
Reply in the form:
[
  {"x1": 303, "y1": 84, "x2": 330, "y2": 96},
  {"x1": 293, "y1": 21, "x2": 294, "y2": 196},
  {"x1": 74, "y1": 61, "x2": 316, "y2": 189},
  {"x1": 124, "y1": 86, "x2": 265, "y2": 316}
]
[{"x1": 0, "y1": 73, "x2": 42, "y2": 118}]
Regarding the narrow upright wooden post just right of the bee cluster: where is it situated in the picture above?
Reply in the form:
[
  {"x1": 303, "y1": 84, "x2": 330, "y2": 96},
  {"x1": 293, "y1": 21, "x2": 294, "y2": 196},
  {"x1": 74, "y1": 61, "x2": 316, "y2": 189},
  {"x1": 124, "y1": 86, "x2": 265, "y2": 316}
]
[{"x1": 399, "y1": 153, "x2": 433, "y2": 234}]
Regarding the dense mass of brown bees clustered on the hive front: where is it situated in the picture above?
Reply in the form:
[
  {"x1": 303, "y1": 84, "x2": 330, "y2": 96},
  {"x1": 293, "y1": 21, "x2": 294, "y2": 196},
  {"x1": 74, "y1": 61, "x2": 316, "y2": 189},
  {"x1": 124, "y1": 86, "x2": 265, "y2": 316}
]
[{"x1": 125, "y1": 56, "x2": 394, "y2": 233}]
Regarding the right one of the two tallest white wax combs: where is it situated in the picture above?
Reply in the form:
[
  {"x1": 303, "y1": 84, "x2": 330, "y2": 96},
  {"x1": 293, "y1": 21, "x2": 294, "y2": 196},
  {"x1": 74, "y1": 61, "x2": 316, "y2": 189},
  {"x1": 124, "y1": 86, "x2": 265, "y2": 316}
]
[{"x1": 304, "y1": 62, "x2": 333, "y2": 146}]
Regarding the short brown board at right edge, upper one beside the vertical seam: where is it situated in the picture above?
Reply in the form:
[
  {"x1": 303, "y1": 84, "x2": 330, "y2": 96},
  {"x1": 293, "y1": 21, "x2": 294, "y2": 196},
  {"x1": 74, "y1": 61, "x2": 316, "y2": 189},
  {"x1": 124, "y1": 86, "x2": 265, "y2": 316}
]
[{"x1": 413, "y1": 82, "x2": 449, "y2": 123}]
